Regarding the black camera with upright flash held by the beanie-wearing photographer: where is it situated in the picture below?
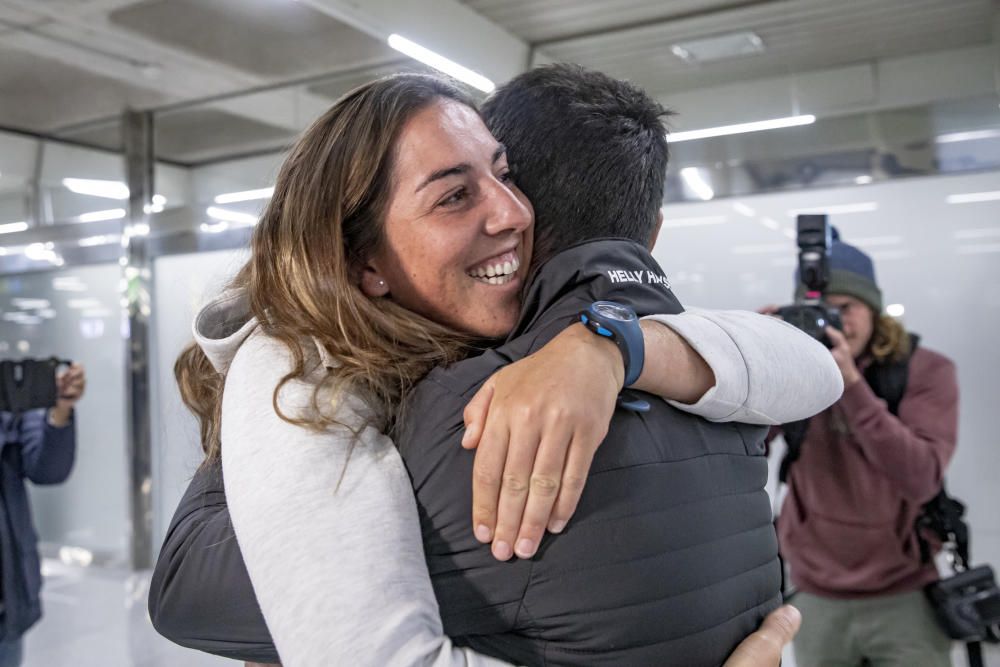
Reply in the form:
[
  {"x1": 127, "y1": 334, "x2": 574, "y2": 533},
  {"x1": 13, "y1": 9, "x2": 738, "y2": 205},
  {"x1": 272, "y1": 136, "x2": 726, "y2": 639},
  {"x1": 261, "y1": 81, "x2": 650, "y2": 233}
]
[{"x1": 778, "y1": 214, "x2": 844, "y2": 347}]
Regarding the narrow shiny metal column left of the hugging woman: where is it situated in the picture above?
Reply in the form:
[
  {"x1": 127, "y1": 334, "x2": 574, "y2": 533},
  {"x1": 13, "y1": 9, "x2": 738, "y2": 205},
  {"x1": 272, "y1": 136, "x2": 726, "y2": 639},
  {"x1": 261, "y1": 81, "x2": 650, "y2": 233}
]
[{"x1": 121, "y1": 111, "x2": 153, "y2": 570}]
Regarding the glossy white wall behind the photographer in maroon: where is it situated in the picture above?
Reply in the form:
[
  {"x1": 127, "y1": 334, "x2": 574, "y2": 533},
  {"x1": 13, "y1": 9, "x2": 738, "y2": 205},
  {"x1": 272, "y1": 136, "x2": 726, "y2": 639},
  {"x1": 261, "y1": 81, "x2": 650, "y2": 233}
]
[{"x1": 654, "y1": 172, "x2": 1000, "y2": 566}]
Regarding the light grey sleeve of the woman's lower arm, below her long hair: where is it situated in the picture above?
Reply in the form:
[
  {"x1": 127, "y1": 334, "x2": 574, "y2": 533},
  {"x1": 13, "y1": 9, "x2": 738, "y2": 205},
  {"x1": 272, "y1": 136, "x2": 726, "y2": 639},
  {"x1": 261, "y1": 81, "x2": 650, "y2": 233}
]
[{"x1": 222, "y1": 334, "x2": 516, "y2": 667}]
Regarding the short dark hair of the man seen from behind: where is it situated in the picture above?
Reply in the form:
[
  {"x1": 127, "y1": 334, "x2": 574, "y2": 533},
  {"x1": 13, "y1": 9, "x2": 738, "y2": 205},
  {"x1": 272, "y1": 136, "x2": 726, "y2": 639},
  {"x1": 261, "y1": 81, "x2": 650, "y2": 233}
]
[{"x1": 482, "y1": 64, "x2": 670, "y2": 266}]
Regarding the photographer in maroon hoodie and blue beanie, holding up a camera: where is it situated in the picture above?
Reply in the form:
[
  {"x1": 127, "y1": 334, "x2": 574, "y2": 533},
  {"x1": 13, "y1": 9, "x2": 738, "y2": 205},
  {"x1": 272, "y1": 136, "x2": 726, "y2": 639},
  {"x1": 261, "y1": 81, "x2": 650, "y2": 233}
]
[{"x1": 766, "y1": 236, "x2": 958, "y2": 667}]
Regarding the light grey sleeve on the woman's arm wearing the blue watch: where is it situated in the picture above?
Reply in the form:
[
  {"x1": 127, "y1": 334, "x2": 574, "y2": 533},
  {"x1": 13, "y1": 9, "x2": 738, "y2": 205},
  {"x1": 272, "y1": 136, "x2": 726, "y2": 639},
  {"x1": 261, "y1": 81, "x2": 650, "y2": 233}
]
[{"x1": 643, "y1": 308, "x2": 844, "y2": 425}]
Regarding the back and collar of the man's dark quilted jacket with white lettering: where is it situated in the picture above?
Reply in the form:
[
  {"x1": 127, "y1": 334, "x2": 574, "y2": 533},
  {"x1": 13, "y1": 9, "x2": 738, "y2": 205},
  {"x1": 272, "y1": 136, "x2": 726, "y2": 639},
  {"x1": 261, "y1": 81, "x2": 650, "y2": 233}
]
[{"x1": 397, "y1": 241, "x2": 781, "y2": 666}]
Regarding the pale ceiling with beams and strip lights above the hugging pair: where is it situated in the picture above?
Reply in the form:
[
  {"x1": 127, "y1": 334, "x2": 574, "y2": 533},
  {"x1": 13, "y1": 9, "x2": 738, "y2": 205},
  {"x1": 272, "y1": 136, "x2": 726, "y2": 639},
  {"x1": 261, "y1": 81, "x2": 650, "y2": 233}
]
[{"x1": 0, "y1": 0, "x2": 1000, "y2": 162}]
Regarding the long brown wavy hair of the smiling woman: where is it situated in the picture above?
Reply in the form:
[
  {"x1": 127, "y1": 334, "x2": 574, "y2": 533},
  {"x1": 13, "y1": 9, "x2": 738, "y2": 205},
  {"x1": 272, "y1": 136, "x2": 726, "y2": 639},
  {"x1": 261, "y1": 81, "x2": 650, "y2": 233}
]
[{"x1": 174, "y1": 74, "x2": 475, "y2": 461}]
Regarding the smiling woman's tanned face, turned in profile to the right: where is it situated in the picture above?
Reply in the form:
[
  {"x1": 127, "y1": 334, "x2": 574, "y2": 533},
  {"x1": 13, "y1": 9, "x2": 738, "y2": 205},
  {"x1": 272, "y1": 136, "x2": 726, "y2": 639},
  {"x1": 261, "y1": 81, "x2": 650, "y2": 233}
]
[{"x1": 361, "y1": 100, "x2": 534, "y2": 338}]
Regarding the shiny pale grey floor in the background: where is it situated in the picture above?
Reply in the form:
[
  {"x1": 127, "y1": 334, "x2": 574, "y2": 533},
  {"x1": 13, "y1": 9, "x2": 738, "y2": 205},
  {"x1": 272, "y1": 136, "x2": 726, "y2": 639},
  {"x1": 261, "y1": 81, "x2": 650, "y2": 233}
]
[{"x1": 24, "y1": 559, "x2": 1000, "y2": 667}]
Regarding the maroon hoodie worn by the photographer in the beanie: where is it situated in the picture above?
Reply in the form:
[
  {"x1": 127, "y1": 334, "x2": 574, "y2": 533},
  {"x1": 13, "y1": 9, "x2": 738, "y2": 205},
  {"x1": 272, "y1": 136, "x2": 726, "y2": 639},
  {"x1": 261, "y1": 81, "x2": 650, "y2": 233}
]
[{"x1": 778, "y1": 347, "x2": 958, "y2": 598}]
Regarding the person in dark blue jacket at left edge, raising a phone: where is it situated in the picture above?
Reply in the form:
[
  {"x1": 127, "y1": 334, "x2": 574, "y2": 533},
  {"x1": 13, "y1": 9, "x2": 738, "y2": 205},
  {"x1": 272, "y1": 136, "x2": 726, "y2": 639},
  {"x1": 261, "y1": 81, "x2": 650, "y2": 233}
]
[{"x1": 0, "y1": 364, "x2": 86, "y2": 667}]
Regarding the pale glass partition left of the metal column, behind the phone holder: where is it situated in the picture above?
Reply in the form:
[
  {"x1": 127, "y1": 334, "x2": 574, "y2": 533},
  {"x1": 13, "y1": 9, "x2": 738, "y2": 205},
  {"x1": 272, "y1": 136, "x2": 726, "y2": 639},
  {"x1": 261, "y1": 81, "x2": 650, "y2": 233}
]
[{"x1": 0, "y1": 263, "x2": 128, "y2": 565}]
